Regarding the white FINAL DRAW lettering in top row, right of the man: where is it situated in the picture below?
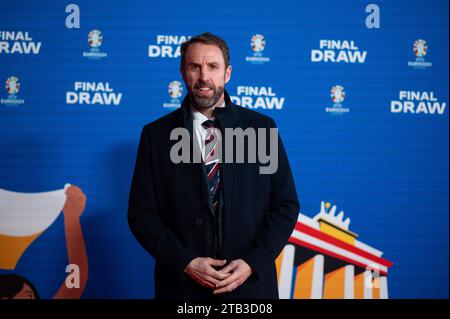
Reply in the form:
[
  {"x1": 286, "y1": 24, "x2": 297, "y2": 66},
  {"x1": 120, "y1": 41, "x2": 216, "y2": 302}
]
[{"x1": 311, "y1": 39, "x2": 367, "y2": 64}]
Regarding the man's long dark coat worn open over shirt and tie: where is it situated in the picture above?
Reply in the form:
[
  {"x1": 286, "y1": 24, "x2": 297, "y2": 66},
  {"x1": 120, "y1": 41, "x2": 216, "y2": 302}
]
[{"x1": 128, "y1": 92, "x2": 300, "y2": 299}]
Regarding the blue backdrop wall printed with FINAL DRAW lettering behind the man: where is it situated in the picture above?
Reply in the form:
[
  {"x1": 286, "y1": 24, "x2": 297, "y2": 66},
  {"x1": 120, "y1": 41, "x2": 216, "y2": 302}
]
[{"x1": 0, "y1": 0, "x2": 449, "y2": 298}]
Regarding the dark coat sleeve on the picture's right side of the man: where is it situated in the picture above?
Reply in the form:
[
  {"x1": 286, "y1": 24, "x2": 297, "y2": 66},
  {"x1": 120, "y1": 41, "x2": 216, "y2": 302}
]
[{"x1": 242, "y1": 120, "x2": 300, "y2": 277}]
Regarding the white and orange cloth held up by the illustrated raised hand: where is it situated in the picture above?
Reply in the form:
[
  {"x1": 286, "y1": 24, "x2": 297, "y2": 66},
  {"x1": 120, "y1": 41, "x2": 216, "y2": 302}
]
[{"x1": 0, "y1": 184, "x2": 70, "y2": 269}]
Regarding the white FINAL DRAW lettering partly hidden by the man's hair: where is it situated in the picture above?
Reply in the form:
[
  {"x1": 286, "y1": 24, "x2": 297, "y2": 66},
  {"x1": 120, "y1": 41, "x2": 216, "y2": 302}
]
[{"x1": 148, "y1": 34, "x2": 191, "y2": 59}]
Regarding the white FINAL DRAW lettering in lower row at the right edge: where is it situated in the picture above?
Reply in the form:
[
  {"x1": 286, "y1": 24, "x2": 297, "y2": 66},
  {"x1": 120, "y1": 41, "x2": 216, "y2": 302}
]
[{"x1": 391, "y1": 91, "x2": 447, "y2": 115}]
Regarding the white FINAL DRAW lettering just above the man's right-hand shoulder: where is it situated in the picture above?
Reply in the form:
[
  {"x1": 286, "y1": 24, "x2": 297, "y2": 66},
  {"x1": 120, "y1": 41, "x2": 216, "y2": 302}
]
[{"x1": 230, "y1": 85, "x2": 285, "y2": 110}]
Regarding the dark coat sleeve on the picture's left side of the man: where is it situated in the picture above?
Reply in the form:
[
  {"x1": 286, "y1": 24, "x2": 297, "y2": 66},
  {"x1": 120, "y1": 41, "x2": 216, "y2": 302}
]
[{"x1": 128, "y1": 126, "x2": 197, "y2": 276}]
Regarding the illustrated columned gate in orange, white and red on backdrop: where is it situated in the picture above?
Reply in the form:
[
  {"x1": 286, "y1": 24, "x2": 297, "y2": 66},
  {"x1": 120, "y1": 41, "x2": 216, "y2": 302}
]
[{"x1": 276, "y1": 202, "x2": 393, "y2": 299}]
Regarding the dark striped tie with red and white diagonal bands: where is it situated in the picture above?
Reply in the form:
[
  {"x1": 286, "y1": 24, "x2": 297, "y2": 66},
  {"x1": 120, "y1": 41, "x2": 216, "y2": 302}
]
[{"x1": 202, "y1": 118, "x2": 221, "y2": 211}]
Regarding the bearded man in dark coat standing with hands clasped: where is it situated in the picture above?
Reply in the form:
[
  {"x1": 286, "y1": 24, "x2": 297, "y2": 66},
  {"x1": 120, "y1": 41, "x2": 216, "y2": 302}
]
[{"x1": 128, "y1": 33, "x2": 300, "y2": 299}]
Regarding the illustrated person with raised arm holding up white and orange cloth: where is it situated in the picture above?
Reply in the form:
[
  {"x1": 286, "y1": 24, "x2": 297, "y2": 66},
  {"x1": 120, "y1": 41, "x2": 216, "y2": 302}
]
[{"x1": 0, "y1": 184, "x2": 88, "y2": 298}]
